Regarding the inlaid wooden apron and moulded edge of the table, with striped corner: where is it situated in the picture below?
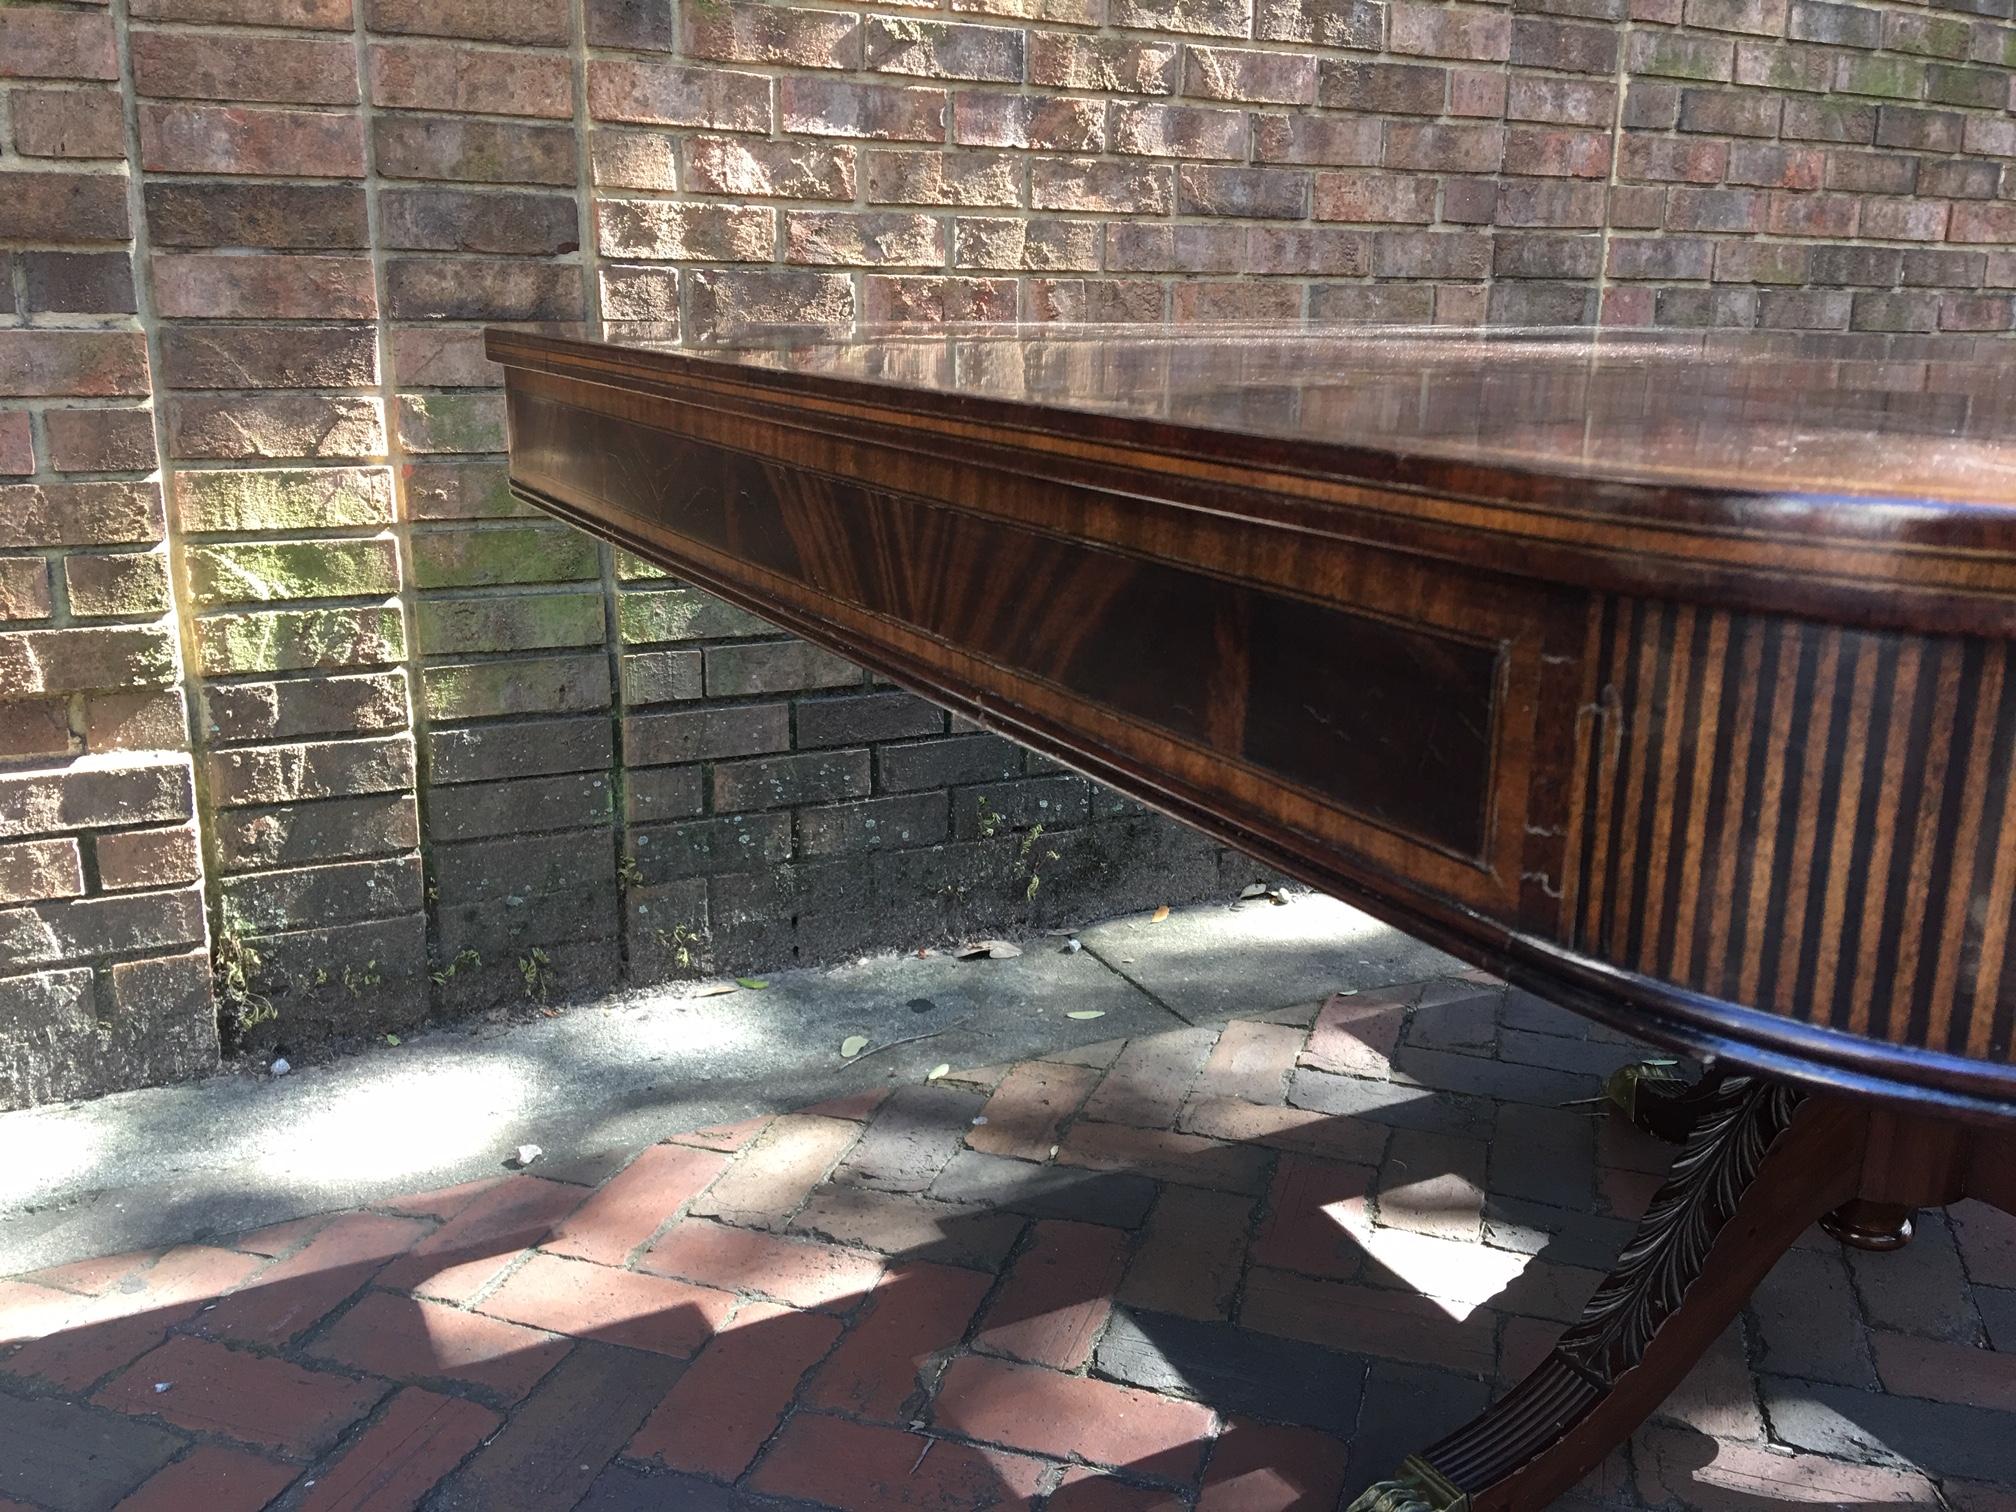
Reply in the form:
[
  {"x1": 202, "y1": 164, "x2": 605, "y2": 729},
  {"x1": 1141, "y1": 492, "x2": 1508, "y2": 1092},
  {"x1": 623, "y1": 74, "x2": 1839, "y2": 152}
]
[{"x1": 490, "y1": 322, "x2": 2016, "y2": 1117}]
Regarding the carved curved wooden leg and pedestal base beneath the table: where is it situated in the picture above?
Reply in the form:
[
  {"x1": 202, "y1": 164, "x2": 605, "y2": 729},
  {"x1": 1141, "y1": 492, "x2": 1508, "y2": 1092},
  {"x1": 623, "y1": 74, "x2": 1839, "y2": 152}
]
[{"x1": 1351, "y1": 1075, "x2": 2016, "y2": 1512}]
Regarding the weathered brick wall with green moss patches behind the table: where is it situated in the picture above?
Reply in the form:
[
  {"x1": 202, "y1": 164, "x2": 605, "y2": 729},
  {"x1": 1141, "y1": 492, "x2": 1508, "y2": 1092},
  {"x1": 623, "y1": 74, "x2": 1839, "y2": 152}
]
[{"x1": 0, "y1": 0, "x2": 2016, "y2": 1103}]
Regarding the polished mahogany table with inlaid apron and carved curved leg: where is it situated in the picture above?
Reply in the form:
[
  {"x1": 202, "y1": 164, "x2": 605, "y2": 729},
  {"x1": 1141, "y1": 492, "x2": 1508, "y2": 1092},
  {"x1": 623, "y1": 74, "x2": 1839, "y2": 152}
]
[{"x1": 488, "y1": 325, "x2": 2016, "y2": 1512}]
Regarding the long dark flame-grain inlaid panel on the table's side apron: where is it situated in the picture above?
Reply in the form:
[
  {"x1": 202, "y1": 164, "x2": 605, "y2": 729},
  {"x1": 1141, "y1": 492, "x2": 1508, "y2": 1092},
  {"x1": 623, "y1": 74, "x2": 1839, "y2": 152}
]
[{"x1": 512, "y1": 391, "x2": 1500, "y2": 861}]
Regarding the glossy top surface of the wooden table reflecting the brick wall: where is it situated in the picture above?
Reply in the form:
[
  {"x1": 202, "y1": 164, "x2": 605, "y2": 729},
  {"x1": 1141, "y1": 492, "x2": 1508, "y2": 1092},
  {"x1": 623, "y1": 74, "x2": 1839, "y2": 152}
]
[{"x1": 532, "y1": 325, "x2": 2016, "y2": 506}]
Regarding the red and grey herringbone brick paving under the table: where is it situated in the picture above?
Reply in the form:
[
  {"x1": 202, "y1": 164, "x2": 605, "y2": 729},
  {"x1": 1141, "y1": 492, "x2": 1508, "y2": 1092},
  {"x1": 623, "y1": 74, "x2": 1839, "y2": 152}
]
[{"x1": 0, "y1": 974, "x2": 2016, "y2": 1512}]
